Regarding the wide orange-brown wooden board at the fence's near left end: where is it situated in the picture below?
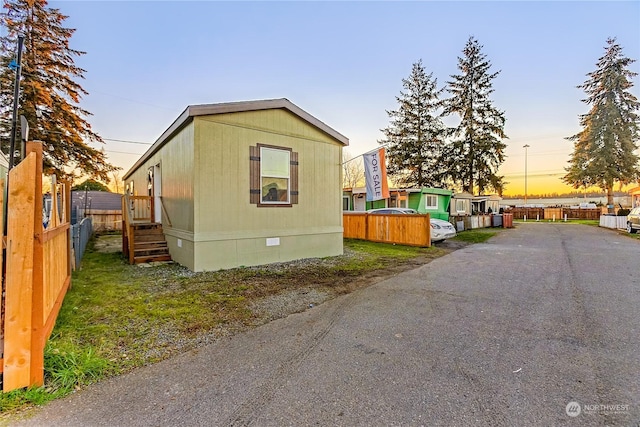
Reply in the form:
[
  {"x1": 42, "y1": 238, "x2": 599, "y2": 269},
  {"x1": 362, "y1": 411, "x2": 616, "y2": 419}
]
[{"x1": 3, "y1": 153, "x2": 36, "y2": 391}]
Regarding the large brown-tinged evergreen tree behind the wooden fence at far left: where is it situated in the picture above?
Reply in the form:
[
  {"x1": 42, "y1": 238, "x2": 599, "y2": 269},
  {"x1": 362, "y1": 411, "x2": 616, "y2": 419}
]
[{"x1": 0, "y1": 0, "x2": 117, "y2": 181}]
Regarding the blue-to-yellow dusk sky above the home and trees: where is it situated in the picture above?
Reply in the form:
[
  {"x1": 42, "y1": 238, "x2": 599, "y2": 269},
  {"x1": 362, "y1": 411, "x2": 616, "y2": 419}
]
[{"x1": 11, "y1": 1, "x2": 640, "y2": 194}]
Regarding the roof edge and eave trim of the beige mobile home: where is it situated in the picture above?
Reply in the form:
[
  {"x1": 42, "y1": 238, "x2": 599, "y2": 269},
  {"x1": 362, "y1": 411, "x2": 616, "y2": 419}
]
[{"x1": 123, "y1": 98, "x2": 349, "y2": 180}]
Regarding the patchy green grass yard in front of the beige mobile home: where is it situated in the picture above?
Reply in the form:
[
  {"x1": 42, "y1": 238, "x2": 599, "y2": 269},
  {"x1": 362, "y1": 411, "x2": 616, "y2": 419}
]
[{"x1": 0, "y1": 236, "x2": 450, "y2": 419}]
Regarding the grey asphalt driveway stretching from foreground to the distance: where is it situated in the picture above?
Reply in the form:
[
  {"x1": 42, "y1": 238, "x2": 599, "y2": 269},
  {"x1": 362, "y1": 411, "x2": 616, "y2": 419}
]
[{"x1": 13, "y1": 223, "x2": 640, "y2": 426}]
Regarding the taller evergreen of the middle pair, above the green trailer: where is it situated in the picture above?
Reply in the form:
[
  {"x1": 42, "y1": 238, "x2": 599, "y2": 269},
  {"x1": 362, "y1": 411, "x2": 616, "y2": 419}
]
[{"x1": 443, "y1": 37, "x2": 507, "y2": 194}]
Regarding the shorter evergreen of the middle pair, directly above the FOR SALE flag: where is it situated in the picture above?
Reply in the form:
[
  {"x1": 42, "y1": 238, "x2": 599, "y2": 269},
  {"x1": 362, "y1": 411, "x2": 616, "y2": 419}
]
[{"x1": 378, "y1": 60, "x2": 446, "y2": 187}]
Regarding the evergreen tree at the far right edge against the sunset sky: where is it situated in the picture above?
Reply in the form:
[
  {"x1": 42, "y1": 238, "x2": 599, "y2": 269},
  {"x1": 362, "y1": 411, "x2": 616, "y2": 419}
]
[{"x1": 562, "y1": 39, "x2": 640, "y2": 213}]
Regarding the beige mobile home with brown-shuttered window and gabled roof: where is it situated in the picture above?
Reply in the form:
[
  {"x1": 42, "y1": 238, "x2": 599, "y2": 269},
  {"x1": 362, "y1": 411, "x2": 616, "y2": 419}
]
[{"x1": 124, "y1": 99, "x2": 349, "y2": 271}]
